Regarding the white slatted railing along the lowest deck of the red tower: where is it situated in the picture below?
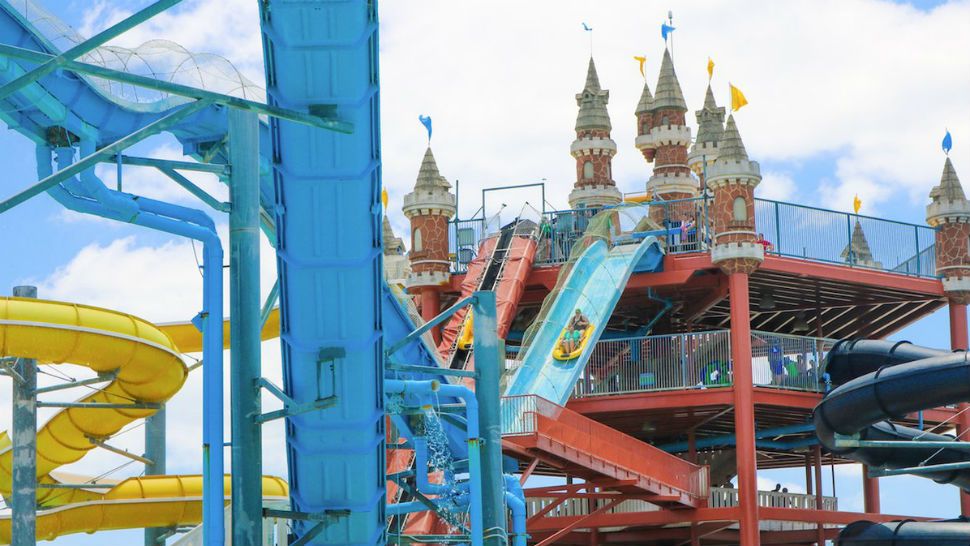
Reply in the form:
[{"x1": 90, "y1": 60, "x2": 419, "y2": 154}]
[{"x1": 525, "y1": 487, "x2": 839, "y2": 530}]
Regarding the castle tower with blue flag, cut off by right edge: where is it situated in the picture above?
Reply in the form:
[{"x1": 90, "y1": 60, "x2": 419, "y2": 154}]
[{"x1": 926, "y1": 157, "x2": 970, "y2": 304}]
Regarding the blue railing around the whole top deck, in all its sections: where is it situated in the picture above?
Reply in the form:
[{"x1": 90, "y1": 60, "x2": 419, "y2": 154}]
[{"x1": 449, "y1": 197, "x2": 936, "y2": 277}]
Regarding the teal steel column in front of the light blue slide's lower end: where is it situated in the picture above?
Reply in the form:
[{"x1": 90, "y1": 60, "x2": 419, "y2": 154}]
[{"x1": 472, "y1": 292, "x2": 508, "y2": 546}]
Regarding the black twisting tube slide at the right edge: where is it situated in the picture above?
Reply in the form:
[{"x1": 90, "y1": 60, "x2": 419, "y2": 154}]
[{"x1": 814, "y1": 340, "x2": 970, "y2": 546}]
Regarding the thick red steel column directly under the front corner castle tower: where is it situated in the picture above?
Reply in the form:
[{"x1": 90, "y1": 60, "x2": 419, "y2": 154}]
[{"x1": 728, "y1": 273, "x2": 761, "y2": 546}]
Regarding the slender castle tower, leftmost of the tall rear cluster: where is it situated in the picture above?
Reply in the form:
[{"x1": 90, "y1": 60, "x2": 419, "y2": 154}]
[{"x1": 569, "y1": 57, "x2": 622, "y2": 209}]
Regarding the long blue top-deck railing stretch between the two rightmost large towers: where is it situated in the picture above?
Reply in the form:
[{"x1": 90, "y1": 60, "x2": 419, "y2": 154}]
[{"x1": 754, "y1": 199, "x2": 936, "y2": 277}]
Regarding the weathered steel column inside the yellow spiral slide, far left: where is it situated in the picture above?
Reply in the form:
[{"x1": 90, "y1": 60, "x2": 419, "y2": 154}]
[{"x1": 10, "y1": 286, "x2": 37, "y2": 546}]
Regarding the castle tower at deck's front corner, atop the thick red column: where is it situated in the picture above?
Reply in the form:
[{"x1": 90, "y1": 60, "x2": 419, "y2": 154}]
[{"x1": 707, "y1": 115, "x2": 765, "y2": 274}]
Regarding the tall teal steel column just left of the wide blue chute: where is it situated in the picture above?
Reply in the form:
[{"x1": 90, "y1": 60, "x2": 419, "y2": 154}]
[{"x1": 229, "y1": 109, "x2": 263, "y2": 546}]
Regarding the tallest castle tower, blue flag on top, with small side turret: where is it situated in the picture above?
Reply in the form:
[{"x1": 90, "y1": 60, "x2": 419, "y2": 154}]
[{"x1": 637, "y1": 50, "x2": 698, "y2": 201}]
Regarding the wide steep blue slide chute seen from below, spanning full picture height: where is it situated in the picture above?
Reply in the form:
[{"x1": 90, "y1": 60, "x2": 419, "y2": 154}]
[{"x1": 259, "y1": 0, "x2": 387, "y2": 546}]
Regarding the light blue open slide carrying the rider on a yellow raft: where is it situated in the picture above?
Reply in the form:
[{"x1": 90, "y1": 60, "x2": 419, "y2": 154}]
[{"x1": 505, "y1": 237, "x2": 664, "y2": 404}]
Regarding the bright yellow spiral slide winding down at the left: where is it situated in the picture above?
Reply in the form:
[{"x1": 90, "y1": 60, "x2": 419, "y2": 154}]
[{"x1": 0, "y1": 298, "x2": 288, "y2": 544}]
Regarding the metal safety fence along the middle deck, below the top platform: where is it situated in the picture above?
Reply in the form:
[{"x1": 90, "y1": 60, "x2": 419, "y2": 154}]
[{"x1": 564, "y1": 330, "x2": 834, "y2": 398}]
